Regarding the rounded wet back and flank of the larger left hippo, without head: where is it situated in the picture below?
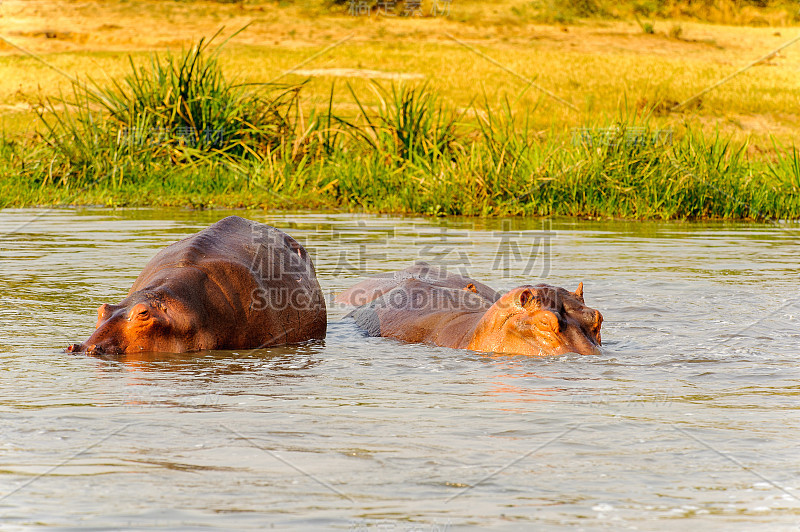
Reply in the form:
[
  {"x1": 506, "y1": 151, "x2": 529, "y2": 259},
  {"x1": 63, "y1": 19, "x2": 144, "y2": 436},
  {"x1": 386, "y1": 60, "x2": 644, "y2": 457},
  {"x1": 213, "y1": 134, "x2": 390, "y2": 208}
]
[{"x1": 129, "y1": 216, "x2": 327, "y2": 346}]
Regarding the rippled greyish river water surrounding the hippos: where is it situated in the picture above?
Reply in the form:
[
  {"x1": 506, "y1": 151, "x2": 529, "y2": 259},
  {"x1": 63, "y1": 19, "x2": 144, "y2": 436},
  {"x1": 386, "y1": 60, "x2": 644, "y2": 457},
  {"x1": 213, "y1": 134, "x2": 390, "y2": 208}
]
[{"x1": 0, "y1": 209, "x2": 800, "y2": 531}]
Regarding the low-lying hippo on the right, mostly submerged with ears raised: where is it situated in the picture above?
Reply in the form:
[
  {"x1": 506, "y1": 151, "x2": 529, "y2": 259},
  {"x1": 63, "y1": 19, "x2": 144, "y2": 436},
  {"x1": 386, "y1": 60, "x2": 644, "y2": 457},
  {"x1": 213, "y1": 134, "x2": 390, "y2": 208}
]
[{"x1": 336, "y1": 263, "x2": 603, "y2": 355}]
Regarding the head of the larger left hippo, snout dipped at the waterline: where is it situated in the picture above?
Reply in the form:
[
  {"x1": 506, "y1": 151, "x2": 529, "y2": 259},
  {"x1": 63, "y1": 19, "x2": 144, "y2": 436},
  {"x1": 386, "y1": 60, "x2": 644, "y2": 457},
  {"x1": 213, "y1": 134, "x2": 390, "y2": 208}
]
[{"x1": 67, "y1": 292, "x2": 208, "y2": 356}]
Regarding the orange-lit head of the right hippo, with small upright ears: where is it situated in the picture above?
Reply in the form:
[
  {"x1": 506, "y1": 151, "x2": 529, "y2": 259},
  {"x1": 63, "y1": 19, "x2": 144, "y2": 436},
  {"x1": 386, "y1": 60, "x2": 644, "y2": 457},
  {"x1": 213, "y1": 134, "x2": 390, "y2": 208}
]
[{"x1": 469, "y1": 283, "x2": 603, "y2": 355}]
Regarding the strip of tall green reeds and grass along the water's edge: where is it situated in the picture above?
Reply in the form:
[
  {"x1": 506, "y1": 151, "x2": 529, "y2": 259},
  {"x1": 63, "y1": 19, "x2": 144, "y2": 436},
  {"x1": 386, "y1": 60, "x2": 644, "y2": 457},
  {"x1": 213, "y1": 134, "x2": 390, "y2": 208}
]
[{"x1": 0, "y1": 35, "x2": 800, "y2": 219}]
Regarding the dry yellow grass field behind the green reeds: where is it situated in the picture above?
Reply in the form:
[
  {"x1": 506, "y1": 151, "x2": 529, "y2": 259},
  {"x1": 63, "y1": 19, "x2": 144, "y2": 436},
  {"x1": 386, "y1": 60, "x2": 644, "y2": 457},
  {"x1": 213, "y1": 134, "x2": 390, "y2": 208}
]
[{"x1": 0, "y1": 0, "x2": 800, "y2": 150}]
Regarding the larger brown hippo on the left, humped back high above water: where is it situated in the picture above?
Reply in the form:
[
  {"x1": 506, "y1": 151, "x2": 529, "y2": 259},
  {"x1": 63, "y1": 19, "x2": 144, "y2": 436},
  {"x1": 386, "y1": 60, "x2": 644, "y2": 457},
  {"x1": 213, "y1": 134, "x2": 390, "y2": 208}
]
[{"x1": 67, "y1": 216, "x2": 327, "y2": 355}]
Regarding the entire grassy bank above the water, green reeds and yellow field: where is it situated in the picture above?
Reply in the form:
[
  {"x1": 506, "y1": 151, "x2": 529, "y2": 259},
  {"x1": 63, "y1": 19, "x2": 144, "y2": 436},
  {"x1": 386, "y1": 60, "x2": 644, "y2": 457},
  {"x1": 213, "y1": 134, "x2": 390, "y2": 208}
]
[{"x1": 0, "y1": 1, "x2": 800, "y2": 219}]
